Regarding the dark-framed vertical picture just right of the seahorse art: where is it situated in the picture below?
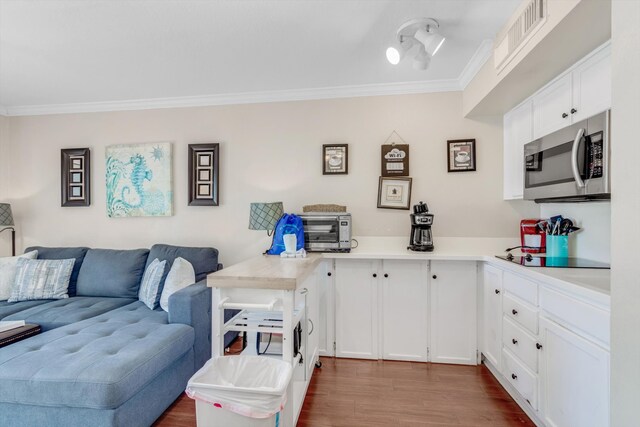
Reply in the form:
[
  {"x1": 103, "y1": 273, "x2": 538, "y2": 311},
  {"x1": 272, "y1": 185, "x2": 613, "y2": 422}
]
[{"x1": 189, "y1": 143, "x2": 220, "y2": 206}]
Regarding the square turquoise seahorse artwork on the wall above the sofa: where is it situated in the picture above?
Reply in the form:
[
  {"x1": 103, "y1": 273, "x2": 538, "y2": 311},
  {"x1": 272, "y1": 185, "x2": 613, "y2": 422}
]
[{"x1": 106, "y1": 142, "x2": 173, "y2": 218}]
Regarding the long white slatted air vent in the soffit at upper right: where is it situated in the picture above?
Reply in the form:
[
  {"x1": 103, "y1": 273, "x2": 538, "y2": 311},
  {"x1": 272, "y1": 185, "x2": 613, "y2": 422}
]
[{"x1": 493, "y1": 0, "x2": 547, "y2": 71}]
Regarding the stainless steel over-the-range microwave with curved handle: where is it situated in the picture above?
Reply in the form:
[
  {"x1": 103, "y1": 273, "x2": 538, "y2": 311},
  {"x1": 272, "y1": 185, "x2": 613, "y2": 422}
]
[{"x1": 524, "y1": 110, "x2": 611, "y2": 203}]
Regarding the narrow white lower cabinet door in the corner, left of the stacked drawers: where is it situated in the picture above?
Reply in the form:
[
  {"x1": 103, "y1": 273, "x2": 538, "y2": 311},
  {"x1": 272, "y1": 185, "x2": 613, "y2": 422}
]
[{"x1": 481, "y1": 263, "x2": 502, "y2": 369}]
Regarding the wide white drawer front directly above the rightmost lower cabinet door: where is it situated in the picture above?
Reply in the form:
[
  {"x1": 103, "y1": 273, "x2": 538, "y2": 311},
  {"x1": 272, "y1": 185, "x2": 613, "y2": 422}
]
[{"x1": 540, "y1": 286, "x2": 611, "y2": 349}]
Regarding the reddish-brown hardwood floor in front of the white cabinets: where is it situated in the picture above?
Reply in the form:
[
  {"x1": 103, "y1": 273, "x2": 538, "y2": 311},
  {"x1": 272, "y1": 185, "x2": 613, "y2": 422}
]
[{"x1": 154, "y1": 357, "x2": 534, "y2": 427}]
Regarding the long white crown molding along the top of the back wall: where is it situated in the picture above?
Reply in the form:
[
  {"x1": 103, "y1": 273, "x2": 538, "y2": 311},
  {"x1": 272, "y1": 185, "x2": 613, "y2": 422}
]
[{"x1": 6, "y1": 79, "x2": 460, "y2": 116}]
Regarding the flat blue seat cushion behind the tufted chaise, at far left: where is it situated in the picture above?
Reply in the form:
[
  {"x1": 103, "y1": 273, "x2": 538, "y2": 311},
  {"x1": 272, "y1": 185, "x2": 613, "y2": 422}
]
[{"x1": 4, "y1": 297, "x2": 135, "y2": 331}]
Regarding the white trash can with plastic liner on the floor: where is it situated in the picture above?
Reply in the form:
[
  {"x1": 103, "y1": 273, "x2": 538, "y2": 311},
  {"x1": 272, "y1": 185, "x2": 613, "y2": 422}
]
[{"x1": 186, "y1": 356, "x2": 292, "y2": 427}]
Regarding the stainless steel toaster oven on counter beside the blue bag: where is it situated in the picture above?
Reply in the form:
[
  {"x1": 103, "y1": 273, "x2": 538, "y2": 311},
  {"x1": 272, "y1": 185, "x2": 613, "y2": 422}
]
[{"x1": 300, "y1": 212, "x2": 351, "y2": 252}]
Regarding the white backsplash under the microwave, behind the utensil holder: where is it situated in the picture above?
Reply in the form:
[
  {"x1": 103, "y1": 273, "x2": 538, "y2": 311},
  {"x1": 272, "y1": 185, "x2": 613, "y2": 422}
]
[{"x1": 540, "y1": 202, "x2": 611, "y2": 262}]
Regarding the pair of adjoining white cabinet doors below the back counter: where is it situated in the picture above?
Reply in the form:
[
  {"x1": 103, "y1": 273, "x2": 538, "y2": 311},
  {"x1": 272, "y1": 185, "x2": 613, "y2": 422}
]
[{"x1": 335, "y1": 259, "x2": 429, "y2": 361}]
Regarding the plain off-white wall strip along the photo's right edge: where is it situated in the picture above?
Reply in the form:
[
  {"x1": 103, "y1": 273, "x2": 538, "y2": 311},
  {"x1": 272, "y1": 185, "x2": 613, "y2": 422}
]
[{"x1": 611, "y1": 0, "x2": 640, "y2": 426}]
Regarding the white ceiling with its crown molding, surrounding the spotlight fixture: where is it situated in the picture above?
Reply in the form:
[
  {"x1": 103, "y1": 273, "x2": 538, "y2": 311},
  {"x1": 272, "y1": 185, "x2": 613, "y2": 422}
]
[{"x1": 0, "y1": 0, "x2": 520, "y2": 115}]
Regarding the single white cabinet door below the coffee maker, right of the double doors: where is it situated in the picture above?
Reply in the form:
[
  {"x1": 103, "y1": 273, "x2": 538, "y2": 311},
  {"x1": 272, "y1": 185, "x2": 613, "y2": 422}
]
[{"x1": 430, "y1": 261, "x2": 478, "y2": 365}]
